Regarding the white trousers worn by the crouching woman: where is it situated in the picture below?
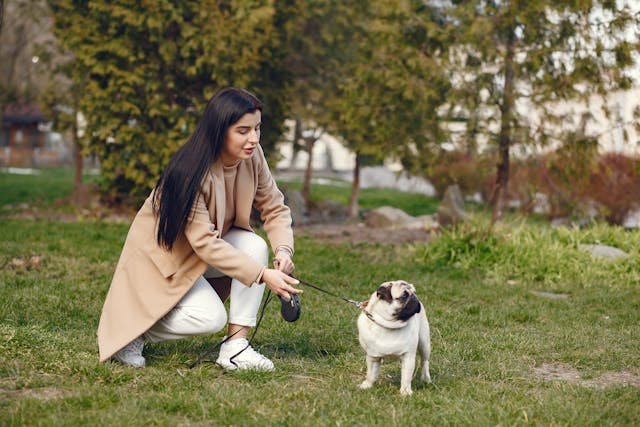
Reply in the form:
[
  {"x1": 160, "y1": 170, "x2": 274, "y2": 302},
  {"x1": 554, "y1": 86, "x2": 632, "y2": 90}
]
[{"x1": 144, "y1": 228, "x2": 269, "y2": 342}]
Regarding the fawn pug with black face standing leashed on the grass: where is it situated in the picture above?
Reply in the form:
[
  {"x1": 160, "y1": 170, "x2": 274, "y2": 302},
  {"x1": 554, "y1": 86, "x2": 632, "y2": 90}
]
[{"x1": 358, "y1": 280, "x2": 431, "y2": 396}]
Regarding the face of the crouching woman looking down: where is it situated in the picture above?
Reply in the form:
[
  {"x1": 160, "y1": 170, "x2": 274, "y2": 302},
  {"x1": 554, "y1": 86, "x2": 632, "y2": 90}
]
[{"x1": 220, "y1": 110, "x2": 262, "y2": 165}]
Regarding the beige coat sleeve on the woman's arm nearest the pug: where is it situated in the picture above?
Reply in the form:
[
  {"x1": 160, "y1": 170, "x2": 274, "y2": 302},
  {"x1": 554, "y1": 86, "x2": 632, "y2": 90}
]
[{"x1": 253, "y1": 145, "x2": 294, "y2": 254}]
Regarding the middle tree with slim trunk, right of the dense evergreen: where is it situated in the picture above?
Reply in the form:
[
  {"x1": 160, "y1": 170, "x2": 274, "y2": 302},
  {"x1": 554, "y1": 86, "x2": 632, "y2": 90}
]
[{"x1": 329, "y1": 0, "x2": 449, "y2": 217}]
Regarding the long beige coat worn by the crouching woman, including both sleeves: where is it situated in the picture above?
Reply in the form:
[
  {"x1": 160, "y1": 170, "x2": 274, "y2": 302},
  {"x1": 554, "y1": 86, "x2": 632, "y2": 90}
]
[{"x1": 98, "y1": 148, "x2": 293, "y2": 361}]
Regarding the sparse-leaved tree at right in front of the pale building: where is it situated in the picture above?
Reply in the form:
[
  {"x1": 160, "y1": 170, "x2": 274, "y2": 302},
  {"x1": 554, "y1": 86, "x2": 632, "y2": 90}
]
[{"x1": 441, "y1": 0, "x2": 639, "y2": 221}]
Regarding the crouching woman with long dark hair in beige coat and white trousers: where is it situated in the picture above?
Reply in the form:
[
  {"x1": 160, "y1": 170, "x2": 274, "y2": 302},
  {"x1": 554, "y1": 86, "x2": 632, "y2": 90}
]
[{"x1": 98, "y1": 88, "x2": 301, "y2": 370}]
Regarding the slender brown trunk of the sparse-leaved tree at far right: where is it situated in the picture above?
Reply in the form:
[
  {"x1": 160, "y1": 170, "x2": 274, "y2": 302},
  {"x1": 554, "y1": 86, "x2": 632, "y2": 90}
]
[{"x1": 491, "y1": 29, "x2": 515, "y2": 224}]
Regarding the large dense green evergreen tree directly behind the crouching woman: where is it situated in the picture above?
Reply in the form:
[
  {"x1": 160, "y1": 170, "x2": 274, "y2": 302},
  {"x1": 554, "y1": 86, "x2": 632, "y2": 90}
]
[{"x1": 50, "y1": 0, "x2": 286, "y2": 203}]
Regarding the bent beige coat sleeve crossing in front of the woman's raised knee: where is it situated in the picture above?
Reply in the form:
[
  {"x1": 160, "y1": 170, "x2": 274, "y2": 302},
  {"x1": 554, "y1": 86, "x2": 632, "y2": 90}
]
[{"x1": 184, "y1": 181, "x2": 265, "y2": 286}]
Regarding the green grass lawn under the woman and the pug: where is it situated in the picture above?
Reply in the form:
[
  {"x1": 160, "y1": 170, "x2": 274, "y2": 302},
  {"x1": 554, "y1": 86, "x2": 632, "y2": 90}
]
[{"x1": 0, "y1": 169, "x2": 640, "y2": 426}]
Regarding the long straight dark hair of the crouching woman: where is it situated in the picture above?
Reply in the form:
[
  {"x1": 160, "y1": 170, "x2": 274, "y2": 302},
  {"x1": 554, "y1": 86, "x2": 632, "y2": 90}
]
[{"x1": 153, "y1": 87, "x2": 262, "y2": 250}]
